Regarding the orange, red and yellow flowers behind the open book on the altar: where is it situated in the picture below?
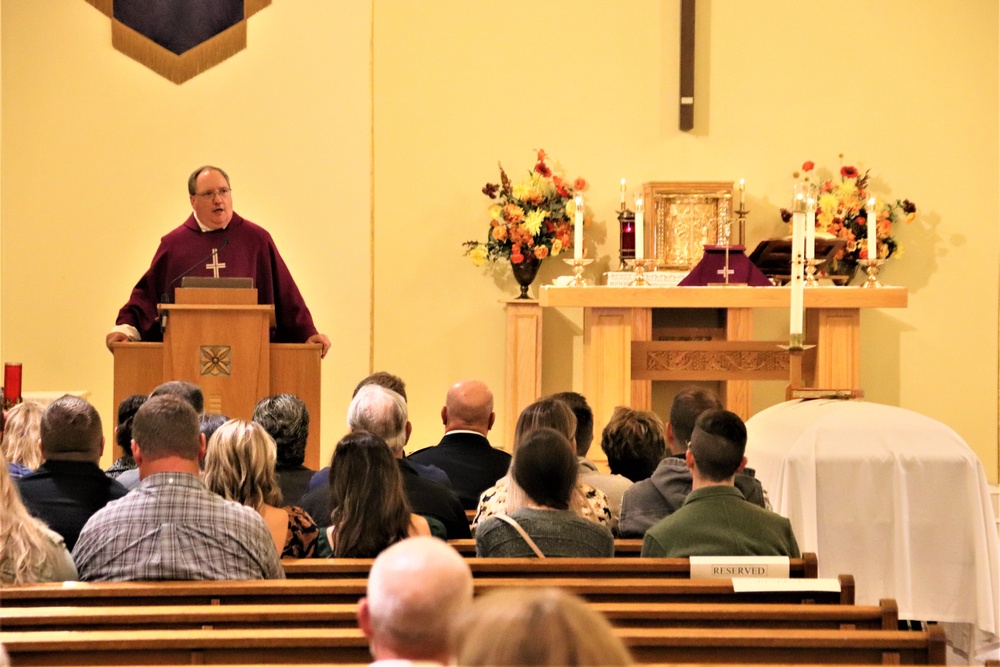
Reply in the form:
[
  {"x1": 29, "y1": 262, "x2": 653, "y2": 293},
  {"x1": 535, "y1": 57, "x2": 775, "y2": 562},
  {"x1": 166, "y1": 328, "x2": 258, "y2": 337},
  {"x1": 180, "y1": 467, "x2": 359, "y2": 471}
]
[{"x1": 781, "y1": 154, "x2": 917, "y2": 272}]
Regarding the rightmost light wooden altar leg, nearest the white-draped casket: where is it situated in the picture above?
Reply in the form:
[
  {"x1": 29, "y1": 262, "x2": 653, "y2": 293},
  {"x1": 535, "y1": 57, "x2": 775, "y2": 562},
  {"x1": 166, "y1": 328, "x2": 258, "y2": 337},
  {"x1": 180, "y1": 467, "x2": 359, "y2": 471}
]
[{"x1": 810, "y1": 308, "x2": 861, "y2": 389}]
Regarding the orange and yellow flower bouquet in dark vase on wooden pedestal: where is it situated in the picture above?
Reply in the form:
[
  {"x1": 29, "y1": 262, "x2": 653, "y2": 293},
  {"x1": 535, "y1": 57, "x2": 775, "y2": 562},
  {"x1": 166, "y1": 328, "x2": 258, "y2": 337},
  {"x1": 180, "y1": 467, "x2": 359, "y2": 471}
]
[{"x1": 463, "y1": 150, "x2": 587, "y2": 266}]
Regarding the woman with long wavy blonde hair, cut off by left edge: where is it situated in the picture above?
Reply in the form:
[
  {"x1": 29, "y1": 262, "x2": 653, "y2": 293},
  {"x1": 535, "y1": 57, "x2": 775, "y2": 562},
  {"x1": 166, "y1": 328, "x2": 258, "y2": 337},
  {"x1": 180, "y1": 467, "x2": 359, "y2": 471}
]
[{"x1": 0, "y1": 452, "x2": 77, "y2": 585}]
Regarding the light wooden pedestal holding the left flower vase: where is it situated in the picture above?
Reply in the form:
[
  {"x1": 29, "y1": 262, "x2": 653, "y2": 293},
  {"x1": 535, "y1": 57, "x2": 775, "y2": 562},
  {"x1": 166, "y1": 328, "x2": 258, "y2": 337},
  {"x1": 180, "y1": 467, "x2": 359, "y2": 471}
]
[{"x1": 504, "y1": 299, "x2": 542, "y2": 451}]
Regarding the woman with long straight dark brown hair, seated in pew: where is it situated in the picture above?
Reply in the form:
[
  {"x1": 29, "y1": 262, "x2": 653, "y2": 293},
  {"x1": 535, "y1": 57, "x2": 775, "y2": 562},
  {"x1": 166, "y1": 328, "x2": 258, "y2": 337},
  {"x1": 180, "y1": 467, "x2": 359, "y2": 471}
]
[{"x1": 316, "y1": 431, "x2": 431, "y2": 558}]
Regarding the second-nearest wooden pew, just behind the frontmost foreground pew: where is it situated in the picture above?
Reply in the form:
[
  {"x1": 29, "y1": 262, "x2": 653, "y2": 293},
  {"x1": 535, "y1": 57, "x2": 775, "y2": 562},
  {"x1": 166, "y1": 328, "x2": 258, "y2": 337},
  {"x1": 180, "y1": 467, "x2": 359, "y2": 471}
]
[{"x1": 0, "y1": 600, "x2": 899, "y2": 632}]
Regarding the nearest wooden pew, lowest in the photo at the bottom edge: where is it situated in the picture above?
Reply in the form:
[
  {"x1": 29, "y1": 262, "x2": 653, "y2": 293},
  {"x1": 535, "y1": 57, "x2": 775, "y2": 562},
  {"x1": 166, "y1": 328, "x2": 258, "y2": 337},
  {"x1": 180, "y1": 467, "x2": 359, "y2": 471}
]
[{"x1": 0, "y1": 626, "x2": 945, "y2": 665}]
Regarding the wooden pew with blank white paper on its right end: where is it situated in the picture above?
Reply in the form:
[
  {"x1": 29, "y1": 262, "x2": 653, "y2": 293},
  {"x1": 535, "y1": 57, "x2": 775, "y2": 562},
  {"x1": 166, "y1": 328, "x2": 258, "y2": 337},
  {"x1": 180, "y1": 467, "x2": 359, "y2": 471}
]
[{"x1": 0, "y1": 574, "x2": 854, "y2": 607}]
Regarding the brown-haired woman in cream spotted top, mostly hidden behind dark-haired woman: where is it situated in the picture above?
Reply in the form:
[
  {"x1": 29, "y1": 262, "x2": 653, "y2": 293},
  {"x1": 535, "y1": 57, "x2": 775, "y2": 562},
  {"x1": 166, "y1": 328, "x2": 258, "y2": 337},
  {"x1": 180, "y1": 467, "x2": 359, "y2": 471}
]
[{"x1": 472, "y1": 398, "x2": 612, "y2": 532}]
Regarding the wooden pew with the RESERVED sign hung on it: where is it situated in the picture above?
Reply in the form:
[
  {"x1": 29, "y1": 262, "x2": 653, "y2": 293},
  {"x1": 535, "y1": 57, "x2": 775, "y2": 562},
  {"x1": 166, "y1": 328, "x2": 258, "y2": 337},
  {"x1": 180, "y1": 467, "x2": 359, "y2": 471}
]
[{"x1": 281, "y1": 553, "x2": 819, "y2": 579}]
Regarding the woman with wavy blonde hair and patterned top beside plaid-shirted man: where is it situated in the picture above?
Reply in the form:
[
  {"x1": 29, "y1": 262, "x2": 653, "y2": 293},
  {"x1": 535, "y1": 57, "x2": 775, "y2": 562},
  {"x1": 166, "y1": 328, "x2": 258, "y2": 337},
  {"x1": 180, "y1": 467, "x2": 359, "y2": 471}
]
[{"x1": 204, "y1": 419, "x2": 319, "y2": 558}]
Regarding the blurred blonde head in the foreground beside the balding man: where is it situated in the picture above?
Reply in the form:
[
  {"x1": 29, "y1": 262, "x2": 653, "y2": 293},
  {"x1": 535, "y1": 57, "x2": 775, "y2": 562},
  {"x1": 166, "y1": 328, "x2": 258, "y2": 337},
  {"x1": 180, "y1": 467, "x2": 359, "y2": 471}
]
[{"x1": 452, "y1": 588, "x2": 633, "y2": 666}]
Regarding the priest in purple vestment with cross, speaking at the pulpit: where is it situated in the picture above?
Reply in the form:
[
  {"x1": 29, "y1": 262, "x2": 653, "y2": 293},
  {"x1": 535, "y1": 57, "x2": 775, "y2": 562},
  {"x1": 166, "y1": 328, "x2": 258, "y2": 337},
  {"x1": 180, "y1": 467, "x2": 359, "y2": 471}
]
[{"x1": 106, "y1": 166, "x2": 330, "y2": 356}]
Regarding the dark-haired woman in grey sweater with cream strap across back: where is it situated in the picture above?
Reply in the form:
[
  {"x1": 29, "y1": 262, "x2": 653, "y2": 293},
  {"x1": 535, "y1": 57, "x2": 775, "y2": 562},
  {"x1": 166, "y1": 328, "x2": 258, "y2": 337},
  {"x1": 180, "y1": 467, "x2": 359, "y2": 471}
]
[{"x1": 476, "y1": 428, "x2": 615, "y2": 558}]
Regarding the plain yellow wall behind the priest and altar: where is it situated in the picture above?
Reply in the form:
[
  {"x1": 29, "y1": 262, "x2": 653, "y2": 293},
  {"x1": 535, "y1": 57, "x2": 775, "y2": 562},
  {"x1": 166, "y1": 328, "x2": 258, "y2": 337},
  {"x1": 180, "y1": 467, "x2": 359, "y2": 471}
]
[{"x1": 0, "y1": 0, "x2": 1000, "y2": 481}]
